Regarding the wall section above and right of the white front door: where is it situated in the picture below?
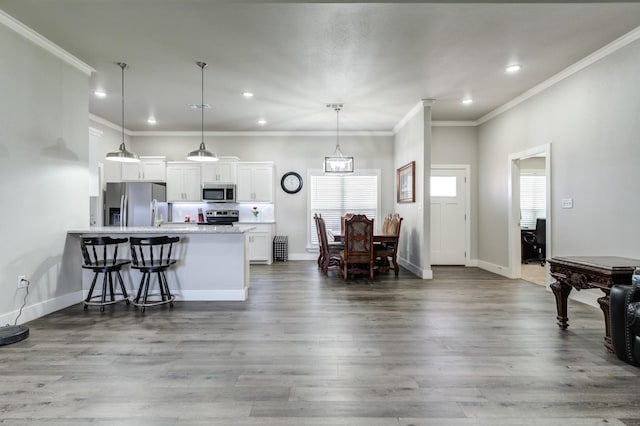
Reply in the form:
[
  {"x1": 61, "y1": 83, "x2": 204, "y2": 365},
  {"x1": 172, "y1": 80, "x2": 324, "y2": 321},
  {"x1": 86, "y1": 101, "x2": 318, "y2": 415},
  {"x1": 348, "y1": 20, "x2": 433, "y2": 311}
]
[{"x1": 431, "y1": 126, "x2": 478, "y2": 261}]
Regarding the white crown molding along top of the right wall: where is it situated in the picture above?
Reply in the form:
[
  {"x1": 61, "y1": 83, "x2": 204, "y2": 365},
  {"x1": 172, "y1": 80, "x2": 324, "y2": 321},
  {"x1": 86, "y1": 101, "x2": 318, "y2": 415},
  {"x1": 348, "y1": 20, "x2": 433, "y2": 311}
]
[{"x1": 477, "y1": 27, "x2": 640, "y2": 125}]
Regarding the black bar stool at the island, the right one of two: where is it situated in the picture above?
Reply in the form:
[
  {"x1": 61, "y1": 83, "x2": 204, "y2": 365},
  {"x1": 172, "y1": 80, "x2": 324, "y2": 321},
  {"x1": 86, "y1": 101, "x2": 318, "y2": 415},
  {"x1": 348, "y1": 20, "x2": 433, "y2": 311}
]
[{"x1": 129, "y1": 236, "x2": 180, "y2": 312}]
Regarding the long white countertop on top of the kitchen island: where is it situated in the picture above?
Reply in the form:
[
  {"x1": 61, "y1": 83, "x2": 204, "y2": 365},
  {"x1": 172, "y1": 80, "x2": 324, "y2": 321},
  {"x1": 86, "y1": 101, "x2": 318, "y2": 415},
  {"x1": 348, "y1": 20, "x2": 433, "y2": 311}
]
[{"x1": 67, "y1": 224, "x2": 254, "y2": 234}]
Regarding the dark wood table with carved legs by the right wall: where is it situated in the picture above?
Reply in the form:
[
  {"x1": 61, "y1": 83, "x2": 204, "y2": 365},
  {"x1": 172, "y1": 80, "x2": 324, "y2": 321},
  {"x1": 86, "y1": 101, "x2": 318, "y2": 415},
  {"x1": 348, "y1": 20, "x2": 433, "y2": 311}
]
[{"x1": 548, "y1": 256, "x2": 640, "y2": 352}]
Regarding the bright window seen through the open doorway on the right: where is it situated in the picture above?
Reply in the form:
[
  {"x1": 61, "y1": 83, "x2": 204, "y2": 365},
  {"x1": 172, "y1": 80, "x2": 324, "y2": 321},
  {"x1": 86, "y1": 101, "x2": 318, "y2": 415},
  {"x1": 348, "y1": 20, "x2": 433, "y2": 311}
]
[{"x1": 520, "y1": 171, "x2": 547, "y2": 229}]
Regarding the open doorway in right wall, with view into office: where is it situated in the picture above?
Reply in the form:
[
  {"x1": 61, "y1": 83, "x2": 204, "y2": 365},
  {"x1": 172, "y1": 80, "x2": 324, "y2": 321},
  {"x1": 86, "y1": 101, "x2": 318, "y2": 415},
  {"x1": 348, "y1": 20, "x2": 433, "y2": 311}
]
[{"x1": 508, "y1": 144, "x2": 551, "y2": 286}]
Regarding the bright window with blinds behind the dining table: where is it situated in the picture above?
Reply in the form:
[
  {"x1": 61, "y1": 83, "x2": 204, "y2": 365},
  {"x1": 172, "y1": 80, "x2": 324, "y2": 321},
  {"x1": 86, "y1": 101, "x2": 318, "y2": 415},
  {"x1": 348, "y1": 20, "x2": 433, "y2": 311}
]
[{"x1": 308, "y1": 171, "x2": 380, "y2": 247}]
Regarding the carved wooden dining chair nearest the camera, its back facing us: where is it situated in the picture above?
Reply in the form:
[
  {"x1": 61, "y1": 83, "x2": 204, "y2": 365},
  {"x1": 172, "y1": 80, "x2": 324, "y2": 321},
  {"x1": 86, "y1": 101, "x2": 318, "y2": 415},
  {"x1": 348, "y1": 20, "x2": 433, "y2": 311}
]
[{"x1": 340, "y1": 214, "x2": 375, "y2": 282}]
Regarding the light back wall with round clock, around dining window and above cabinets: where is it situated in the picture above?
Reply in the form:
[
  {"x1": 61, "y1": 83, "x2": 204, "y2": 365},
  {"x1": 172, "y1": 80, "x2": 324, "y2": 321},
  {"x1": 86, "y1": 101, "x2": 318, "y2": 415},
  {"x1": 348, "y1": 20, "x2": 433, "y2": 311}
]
[{"x1": 125, "y1": 133, "x2": 395, "y2": 260}]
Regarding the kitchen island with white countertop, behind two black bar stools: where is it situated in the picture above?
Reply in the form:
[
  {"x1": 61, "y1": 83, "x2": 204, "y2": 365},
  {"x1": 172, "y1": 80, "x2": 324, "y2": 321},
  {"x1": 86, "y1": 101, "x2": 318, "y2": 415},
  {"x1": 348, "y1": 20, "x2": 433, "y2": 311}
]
[{"x1": 63, "y1": 224, "x2": 253, "y2": 300}]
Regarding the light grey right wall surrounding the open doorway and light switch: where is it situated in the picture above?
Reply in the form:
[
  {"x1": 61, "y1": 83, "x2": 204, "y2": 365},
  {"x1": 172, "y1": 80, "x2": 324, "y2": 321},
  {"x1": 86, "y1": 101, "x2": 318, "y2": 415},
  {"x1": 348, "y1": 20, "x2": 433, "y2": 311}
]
[{"x1": 478, "y1": 37, "x2": 640, "y2": 286}]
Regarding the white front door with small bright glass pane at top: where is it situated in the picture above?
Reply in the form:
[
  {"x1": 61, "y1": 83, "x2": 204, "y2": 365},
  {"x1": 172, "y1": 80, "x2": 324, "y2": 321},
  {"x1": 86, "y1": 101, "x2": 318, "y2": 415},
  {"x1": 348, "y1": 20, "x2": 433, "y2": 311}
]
[{"x1": 431, "y1": 169, "x2": 467, "y2": 265}]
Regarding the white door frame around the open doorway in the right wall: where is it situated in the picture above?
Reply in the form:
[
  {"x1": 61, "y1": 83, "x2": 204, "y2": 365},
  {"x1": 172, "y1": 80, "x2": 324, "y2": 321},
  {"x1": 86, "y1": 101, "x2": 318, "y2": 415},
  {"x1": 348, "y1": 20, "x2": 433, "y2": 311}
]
[{"x1": 508, "y1": 143, "x2": 552, "y2": 287}]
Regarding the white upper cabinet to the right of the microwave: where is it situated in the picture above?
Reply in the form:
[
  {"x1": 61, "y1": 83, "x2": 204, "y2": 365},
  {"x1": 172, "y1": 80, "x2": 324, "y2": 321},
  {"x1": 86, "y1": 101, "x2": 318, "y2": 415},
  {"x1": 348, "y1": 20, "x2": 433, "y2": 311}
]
[{"x1": 236, "y1": 162, "x2": 274, "y2": 203}]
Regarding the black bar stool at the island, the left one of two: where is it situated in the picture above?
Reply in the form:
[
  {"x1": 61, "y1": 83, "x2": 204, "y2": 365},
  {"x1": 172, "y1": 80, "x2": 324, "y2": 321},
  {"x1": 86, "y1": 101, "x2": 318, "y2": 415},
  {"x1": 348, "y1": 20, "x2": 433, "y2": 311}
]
[{"x1": 80, "y1": 237, "x2": 131, "y2": 312}]
